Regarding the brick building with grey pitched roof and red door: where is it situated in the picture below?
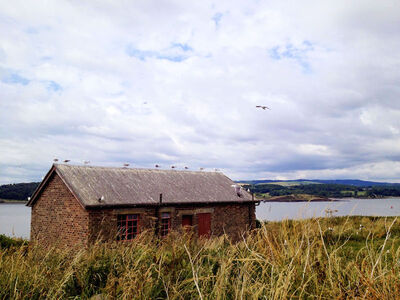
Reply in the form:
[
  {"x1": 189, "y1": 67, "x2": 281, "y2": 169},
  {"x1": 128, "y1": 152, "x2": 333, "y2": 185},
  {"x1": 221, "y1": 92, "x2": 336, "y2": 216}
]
[{"x1": 27, "y1": 164, "x2": 257, "y2": 246}]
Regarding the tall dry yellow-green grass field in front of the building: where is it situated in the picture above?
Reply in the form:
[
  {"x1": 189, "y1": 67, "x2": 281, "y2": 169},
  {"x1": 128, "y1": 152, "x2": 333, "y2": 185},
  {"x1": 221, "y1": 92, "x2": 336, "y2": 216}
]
[{"x1": 0, "y1": 217, "x2": 400, "y2": 299}]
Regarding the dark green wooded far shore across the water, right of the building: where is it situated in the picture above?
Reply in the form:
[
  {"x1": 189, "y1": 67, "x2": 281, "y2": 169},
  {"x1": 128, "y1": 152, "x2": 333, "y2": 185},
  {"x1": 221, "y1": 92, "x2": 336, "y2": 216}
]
[{"x1": 244, "y1": 184, "x2": 400, "y2": 198}]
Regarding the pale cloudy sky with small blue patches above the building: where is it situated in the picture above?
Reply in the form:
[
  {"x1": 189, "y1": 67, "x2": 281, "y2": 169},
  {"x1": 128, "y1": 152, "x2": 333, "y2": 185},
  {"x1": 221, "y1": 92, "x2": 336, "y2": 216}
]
[{"x1": 0, "y1": 0, "x2": 400, "y2": 184}]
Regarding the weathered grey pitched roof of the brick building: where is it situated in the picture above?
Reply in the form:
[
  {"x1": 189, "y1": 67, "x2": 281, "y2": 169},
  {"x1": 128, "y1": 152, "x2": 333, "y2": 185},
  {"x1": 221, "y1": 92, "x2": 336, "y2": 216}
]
[{"x1": 27, "y1": 164, "x2": 255, "y2": 208}]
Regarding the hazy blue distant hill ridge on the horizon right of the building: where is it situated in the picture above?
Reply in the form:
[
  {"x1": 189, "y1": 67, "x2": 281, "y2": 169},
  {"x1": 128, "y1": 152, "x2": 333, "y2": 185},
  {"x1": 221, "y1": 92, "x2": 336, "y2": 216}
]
[{"x1": 236, "y1": 179, "x2": 400, "y2": 187}]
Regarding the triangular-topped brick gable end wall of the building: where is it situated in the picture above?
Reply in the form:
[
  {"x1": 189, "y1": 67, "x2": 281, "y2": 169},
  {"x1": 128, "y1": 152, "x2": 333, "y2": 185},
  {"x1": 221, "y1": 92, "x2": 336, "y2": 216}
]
[{"x1": 31, "y1": 173, "x2": 89, "y2": 247}]
